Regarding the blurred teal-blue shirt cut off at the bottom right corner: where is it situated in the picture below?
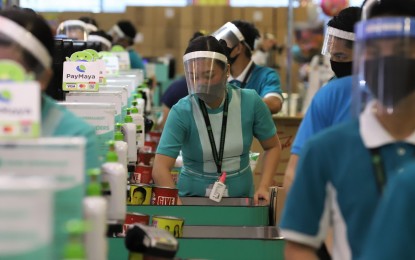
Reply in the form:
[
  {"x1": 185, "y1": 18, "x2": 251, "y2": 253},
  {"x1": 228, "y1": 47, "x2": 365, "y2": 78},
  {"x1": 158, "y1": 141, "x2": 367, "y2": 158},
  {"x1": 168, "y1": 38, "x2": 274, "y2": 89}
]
[{"x1": 359, "y1": 163, "x2": 415, "y2": 260}]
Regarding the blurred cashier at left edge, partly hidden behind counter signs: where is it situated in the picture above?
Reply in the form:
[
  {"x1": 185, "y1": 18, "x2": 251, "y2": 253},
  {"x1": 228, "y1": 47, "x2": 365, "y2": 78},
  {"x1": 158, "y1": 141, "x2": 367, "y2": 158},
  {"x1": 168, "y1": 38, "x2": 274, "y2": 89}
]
[{"x1": 0, "y1": 9, "x2": 100, "y2": 173}]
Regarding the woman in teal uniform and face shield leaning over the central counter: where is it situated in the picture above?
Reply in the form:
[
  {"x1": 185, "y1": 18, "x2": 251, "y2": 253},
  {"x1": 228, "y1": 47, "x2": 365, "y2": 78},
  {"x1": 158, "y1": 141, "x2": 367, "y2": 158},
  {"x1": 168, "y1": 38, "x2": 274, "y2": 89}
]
[{"x1": 153, "y1": 36, "x2": 281, "y2": 203}]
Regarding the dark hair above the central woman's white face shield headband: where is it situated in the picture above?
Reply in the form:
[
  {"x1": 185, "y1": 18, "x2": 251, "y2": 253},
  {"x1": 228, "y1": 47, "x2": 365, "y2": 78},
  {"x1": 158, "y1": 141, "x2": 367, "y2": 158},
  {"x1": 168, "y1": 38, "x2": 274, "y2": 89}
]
[{"x1": 184, "y1": 35, "x2": 229, "y2": 68}]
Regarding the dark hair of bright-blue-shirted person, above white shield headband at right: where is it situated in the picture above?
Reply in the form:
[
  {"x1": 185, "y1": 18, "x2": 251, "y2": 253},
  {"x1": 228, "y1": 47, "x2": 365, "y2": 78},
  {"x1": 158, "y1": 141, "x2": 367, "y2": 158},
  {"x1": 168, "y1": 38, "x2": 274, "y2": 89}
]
[{"x1": 327, "y1": 6, "x2": 362, "y2": 32}]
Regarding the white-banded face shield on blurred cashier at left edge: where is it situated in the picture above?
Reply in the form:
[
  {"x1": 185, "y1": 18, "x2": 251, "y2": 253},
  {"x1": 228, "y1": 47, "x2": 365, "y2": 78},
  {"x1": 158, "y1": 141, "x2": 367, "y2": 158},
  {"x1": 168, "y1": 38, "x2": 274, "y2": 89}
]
[{"x1": 0, "y1": 16, "x2": 52, "y2": 78}]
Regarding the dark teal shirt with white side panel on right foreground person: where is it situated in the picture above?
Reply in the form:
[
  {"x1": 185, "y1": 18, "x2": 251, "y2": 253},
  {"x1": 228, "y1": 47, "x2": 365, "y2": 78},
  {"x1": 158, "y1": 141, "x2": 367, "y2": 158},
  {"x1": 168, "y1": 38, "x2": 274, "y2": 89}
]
[{"x1": 280, "y1": 120, "x2": 415, "y2": 259}]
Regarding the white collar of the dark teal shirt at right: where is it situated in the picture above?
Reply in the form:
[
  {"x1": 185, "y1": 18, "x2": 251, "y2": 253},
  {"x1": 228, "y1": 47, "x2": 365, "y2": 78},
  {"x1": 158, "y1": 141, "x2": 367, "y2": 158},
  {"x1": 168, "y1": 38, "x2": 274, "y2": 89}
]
[{"x1": 359, "y1": 101, "x2": 415, "y2": 149}]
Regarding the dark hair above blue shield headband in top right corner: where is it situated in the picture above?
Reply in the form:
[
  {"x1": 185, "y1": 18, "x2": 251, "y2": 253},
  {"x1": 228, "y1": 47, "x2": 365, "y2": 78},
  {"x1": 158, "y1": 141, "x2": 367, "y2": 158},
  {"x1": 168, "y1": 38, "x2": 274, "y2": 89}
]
[{"x1": 365, "y1": 0, "x2": 415, "y2": 18}]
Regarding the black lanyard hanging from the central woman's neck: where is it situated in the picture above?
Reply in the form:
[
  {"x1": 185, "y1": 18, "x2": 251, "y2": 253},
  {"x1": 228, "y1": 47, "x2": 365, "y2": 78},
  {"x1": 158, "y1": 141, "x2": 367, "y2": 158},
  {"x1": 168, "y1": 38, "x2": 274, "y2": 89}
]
[{"x1": 199, "y1": 92, "x2": 229, "y2": 174}]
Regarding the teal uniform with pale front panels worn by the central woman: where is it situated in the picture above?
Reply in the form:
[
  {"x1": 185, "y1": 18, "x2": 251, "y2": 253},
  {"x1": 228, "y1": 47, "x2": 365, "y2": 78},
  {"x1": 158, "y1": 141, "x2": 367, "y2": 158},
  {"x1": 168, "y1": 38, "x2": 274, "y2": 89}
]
[{"x1": 157, "y1": 84, "x2": 276, "y2": 197}]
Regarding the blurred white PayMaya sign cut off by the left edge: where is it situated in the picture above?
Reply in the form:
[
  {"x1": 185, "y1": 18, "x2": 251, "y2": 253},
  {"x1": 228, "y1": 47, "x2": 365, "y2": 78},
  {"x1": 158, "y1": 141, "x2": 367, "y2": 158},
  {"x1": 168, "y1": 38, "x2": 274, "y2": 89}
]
[{"x1": 0, "y1": 82, "x2": 41, "y2": 139}]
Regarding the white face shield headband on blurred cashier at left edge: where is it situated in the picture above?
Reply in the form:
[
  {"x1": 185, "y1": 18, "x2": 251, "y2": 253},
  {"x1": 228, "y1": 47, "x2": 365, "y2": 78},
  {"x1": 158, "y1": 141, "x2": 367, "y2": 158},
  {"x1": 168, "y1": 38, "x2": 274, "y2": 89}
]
[{"x1": 0, "y1": 16, "x2": 52, "y2": 69}]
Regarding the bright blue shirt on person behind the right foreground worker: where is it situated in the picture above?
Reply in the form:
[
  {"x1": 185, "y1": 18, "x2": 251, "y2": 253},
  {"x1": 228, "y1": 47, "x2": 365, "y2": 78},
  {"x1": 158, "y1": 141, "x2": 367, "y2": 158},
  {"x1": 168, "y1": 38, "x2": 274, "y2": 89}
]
[{"x1": 291, "y1": 76, "x2": 352, "y2": 154}]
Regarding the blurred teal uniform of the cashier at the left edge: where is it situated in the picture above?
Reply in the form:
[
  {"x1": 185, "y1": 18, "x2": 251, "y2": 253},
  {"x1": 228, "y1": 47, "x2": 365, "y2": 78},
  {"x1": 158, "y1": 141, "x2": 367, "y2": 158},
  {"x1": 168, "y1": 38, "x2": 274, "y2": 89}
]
[{"x1": 42, "y1": 94, "x2": 101, "y2": 172}]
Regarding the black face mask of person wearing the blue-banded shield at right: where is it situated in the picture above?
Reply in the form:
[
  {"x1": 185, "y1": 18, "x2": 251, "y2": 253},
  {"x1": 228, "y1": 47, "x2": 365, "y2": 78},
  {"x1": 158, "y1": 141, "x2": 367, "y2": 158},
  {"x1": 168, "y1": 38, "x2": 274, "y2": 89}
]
[{"x1": 365, "y1": 57, "x2": 415, "y2": 108}]
